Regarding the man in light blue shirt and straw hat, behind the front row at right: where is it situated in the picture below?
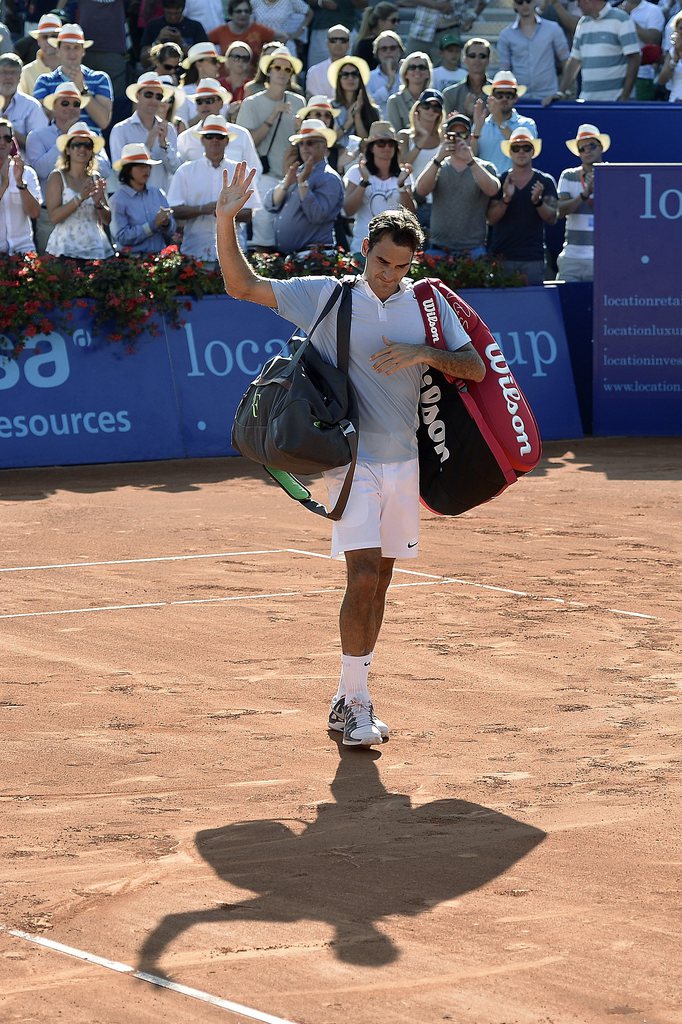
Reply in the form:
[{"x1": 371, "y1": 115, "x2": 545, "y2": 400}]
[{"x1": 471, "y1": 71, "x2": 538, "y2": 173}]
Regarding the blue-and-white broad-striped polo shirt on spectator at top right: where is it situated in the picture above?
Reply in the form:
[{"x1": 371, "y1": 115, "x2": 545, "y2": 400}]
[{"x1": 570, "y1": 4, "x2": 640, "y2": 100}]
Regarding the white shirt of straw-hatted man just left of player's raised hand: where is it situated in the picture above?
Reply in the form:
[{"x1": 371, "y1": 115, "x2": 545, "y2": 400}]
[{"x1": 168, "y1": 155, "x2": 262, "y2": 262}]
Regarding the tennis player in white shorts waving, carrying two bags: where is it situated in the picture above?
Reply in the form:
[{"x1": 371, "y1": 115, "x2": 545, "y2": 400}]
[{"x1": 217, "y1": 164, "x2": 484, "y2": 746}]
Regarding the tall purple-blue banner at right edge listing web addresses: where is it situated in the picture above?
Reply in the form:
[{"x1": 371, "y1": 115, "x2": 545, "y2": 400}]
[{"x1": 593, "y1": 164, "x2": 682, "y2": 436}]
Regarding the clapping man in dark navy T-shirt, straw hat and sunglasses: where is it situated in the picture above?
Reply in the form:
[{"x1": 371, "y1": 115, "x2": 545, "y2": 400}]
[{"x1": 487, "y1": 127, "x2": 557, "y2": 285}]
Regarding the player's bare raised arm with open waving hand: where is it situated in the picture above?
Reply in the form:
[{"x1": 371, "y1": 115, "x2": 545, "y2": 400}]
[{"x1": 215, "y1": 162, "x2": 278, "y2": 309}]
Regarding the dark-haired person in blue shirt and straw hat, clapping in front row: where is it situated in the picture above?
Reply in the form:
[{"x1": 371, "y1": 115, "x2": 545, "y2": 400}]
[{"x1": 110, "y1": 142, "x2": 175, "y2": 253}]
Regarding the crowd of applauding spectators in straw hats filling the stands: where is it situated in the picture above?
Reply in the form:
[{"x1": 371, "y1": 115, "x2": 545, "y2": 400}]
[{"x1": 0, "y1": 0, "x2": 682, "y2": 284}]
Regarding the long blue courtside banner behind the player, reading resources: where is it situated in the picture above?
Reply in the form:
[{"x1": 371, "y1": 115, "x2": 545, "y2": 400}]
[{"x1": 0, "y1": 288, "x2": 582, "y2": 468}]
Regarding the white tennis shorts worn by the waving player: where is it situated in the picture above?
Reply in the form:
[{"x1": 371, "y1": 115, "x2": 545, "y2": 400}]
[{"x1": 325, "y1": 459, "x2": 419, "y2": 558}]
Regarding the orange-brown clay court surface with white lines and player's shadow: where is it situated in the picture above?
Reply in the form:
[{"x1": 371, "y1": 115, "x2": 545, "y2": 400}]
[{"x1": 0, "y1": 439, "x2": 682, "y2": 1024}]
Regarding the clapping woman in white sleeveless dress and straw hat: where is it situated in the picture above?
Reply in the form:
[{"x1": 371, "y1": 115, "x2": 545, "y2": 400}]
[{"x1": 45, "y1": 121, "x2": 114, "y2": 259}]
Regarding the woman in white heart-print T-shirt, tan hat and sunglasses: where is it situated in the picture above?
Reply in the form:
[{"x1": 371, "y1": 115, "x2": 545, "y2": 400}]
[{"x1": 343, "y1": 121, "x2": 415, "y2": 254}]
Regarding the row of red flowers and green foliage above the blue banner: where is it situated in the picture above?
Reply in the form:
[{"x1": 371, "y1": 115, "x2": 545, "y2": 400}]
[{"x1": 0, "y1": 246, "x2": 524, "y2": 357}]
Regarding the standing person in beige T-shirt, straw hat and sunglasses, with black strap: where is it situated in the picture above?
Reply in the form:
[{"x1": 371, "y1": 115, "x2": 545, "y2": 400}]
[{"x1": 237, "y1": 46, "x2": 304, "y2": 249}]
